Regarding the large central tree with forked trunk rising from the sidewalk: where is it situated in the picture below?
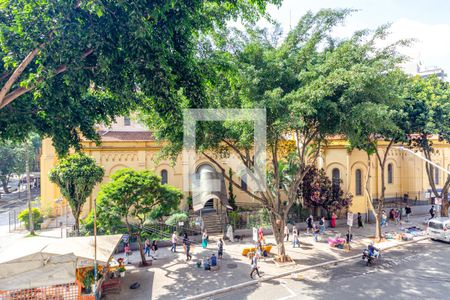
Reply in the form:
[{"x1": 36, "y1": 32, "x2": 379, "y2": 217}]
[{"x1": 144, "y1": 10, "x2": 402, "y2": 260}]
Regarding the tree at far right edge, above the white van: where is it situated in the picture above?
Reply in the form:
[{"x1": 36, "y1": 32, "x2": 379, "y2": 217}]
[{"x1": 405, "y1": 76, "x2": 450, "y2": 217}]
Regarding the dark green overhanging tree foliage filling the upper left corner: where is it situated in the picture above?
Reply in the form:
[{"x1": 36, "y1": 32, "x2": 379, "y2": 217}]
[{"x1": 0, "y1": 0, "x2": 281, "y2": 154}]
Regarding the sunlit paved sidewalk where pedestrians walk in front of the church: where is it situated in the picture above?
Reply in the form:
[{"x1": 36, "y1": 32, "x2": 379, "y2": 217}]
[{"x1": 107, "y1": 216, "x2": 426, "y2": 299}]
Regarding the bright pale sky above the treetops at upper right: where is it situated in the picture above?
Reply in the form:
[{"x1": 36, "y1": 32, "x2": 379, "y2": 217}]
[{"x1": 259, "y1": 0, "x2": 450, "y2": 76}]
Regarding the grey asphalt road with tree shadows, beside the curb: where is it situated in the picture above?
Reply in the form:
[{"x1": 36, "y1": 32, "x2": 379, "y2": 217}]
[{"x1": 213, "y1": 240, "x2": 450, "y2": 300}]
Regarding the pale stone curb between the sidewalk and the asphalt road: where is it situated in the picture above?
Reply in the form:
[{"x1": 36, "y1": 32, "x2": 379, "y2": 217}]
[{"x1": 186, "y1": 236, "x2": 428, "y2": 300}]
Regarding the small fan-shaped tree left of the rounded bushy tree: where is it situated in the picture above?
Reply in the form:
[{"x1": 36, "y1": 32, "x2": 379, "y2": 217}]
[{"x1": 49, "y1": 153, "x2": 105, "y2": 233}]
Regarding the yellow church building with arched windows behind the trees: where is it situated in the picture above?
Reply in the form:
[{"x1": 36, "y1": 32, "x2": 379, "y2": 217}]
[{"x1": 41, "y1": 118, "x2": 450, "y2": 216}]
